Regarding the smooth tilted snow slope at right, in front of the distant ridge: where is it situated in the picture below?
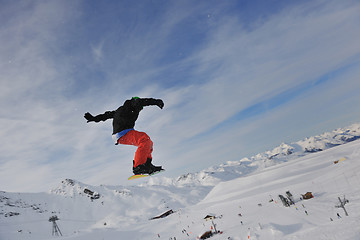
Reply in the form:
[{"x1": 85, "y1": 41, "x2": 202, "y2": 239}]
[{"x1": 196, "y1": 141, "x2": 360, "y2": 239}]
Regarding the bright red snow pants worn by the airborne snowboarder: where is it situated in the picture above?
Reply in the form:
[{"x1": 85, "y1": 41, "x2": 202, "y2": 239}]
[{"x1": 118, "y1": 130, "x2": 153, "y2": 167}]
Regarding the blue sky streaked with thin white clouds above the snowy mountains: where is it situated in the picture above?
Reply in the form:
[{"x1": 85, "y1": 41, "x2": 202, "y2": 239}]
[{"x1": 0, "y1": 0, "x2": 360, "y2": 192}]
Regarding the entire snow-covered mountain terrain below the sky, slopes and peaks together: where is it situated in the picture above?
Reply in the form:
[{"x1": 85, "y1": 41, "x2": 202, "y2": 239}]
[{"x1": 0, "y1": 125, "x2": 360, "y2": 240}]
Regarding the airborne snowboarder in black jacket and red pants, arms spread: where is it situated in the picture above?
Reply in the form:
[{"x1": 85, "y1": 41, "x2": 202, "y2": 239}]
[{"x1": 84, "y1": 97, "x2": 164, "y2": 175}]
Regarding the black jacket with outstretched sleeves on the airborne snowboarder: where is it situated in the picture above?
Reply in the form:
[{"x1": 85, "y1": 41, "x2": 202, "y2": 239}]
[{"x1": 85, "y1": 98, "x2": 164, "y2": 134}]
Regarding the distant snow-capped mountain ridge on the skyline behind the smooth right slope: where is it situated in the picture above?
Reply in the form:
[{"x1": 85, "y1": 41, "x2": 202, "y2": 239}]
[{"x1": 148, "y1": 123, "x2": 360, "y2": 186}]
